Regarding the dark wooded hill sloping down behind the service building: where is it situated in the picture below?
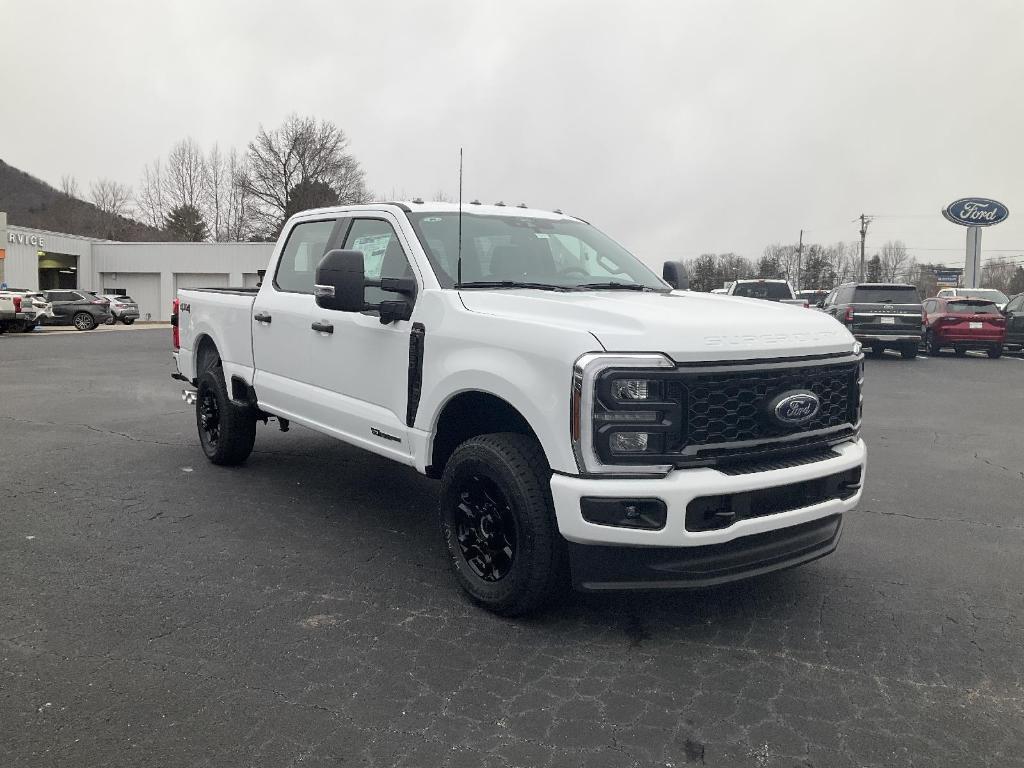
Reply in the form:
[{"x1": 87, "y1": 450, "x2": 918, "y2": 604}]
[{"x1": 0, "y1": 160, "x2": 167, "y2": 242}]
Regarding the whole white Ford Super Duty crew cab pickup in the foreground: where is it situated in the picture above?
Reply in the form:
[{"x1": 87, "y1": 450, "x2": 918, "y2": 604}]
[{"x1": 172, "y1": 202, "x2": 865, "y2": 615}]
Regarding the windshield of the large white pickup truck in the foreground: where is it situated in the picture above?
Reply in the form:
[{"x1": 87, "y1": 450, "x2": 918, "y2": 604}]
[{"x1": 409, "y1": 211, "x2": 671, "y2": 292}]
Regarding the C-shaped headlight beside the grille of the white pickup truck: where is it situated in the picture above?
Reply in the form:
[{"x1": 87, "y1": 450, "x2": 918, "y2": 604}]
[{"x1": 570, "y1": 353, "x2": 682, "y2": 475}]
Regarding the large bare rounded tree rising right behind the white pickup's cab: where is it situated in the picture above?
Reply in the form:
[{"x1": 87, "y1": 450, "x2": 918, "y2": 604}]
[{"x1": 240, "y1": 114, "x2": 369, "y2": 237}]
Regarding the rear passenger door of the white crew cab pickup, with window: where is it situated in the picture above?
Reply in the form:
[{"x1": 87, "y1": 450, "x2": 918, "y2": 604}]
[{"x1": 251, "y1": 217, "x2": 337, "y2": 420}]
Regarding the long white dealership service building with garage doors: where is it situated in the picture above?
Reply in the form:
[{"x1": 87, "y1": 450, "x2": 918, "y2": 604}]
[{"x1": 0, "y1": 212, "x2": 273, "y2": 321}]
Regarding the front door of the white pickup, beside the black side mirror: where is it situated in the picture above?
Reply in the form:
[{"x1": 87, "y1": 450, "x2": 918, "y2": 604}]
[{"x1": 310, "y1": 214, "x2": 414, "y2": 462}]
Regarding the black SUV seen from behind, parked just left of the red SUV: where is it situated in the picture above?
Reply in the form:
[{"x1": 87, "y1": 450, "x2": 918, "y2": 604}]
[{"x1": 818, "y1": 283, "x2": 924, "y2": 359}]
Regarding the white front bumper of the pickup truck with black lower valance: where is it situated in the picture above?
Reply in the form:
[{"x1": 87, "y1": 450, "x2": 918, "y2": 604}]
[{"x1": 551, "y1": 438, "x2": 866, "y2": 589}]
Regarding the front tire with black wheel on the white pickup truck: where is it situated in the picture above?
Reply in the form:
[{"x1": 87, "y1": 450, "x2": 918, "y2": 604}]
[{"x1": 440, "y1": 433, "x2": 568, "y2": 616}]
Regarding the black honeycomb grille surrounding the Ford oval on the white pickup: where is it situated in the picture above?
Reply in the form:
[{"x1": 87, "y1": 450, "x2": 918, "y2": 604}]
[{"x1": 683, "y1": 362, "x2": 860, "y2": 453}]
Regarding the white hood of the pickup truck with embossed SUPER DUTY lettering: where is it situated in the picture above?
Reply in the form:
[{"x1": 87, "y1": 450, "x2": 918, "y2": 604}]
[{"x1": 460, "y1": 289, "x2": 854, "y2": 362}]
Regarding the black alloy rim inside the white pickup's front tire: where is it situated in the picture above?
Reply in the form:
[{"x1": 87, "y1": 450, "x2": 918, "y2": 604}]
[{"x1": 455, "y1": 474, "x2": 519, "y2": 582}]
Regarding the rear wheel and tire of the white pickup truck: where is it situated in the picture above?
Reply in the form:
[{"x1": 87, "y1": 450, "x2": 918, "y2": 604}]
[{"x1": 196, "y1": 366, "x2": 256, "y2": 467}]
